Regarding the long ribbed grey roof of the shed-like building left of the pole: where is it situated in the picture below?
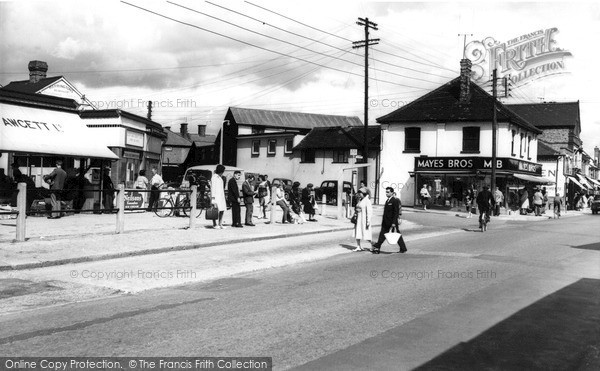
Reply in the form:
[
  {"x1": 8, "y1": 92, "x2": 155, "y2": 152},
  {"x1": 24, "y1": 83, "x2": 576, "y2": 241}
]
[{"x1": 226, "y1": 107, "x2": 362, "y2": 130}]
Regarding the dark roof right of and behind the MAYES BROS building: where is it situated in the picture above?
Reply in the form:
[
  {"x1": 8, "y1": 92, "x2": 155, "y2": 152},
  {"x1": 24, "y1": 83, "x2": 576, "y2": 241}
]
[{"x1": 507, "y1": 102, "x2": 581, "y2": 132}]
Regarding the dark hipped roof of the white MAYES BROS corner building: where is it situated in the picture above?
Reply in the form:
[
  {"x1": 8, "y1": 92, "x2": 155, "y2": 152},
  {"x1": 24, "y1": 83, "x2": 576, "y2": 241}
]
[{"x1": 377, "y1": 76, "x2": 542, "y2": 134}]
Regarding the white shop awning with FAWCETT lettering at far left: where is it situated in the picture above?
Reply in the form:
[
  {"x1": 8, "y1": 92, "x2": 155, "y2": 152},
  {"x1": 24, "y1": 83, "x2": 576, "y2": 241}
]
[{"x1": 0, "y1": 103, "x2": 119, "y2": 160}]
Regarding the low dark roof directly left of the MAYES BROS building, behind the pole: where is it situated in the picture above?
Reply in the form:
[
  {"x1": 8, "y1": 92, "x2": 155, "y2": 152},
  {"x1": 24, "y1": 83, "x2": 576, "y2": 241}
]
[{"x1": 294, "y1": 126, "x2": 381, "y2": 149}]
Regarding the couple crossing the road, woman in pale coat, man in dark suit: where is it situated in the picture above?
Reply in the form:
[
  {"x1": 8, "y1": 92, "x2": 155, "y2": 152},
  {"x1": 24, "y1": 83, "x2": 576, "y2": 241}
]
[{"x1": 353, "y1": 187, "x2": 408, "y2": 254}]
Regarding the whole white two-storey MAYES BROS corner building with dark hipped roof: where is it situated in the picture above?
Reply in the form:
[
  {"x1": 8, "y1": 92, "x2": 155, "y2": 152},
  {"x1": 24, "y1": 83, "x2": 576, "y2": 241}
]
[{"x1": 377, "y1": 59, "x2": 551, "y2": 208}]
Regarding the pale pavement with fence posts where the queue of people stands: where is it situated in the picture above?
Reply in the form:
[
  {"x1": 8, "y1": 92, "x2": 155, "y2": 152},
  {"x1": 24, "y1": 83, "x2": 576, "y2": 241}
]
[{"x1": 0, "y1": 205, "x2": 590, "y2": 271}]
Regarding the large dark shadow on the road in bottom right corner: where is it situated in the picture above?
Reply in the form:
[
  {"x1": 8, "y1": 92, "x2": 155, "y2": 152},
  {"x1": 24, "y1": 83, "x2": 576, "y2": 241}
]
[{"x1": 416, "y1": 280, "x2": 600, "y2": 370}]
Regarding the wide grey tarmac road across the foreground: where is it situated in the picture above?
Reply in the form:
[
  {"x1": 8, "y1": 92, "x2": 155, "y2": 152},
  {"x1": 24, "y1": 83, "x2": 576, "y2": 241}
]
[{"x1": 0, "y1": 216, "x2": 600, "y2": 370}]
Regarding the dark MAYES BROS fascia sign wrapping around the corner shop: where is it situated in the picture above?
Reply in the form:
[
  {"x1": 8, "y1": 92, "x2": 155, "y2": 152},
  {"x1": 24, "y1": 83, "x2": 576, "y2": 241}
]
[{"x1": 415, "y1": 157, "x2": 542, "y2": 175}]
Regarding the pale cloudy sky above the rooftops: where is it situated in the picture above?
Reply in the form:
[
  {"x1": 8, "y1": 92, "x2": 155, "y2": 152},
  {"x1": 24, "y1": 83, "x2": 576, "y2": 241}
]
[{"x1": 0, "y1": 0, "x2": 600, "y2": 155}]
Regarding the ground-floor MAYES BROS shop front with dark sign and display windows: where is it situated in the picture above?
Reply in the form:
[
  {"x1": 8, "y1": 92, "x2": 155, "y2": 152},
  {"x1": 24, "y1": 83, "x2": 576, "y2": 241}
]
[{"x1": 414, "y1": 156, "x2": 552, "y2": 210}]
